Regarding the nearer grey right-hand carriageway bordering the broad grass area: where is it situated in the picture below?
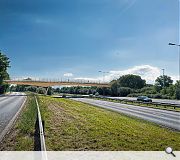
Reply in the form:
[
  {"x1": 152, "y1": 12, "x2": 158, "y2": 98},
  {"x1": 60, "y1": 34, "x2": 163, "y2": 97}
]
[{"x1": 72, "y1": 98, "x2": 180, "y2": 131}]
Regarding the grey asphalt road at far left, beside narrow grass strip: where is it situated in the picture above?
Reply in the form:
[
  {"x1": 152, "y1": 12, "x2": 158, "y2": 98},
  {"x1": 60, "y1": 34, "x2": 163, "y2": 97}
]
[{"x1": 0, "y1": 92, "x2": 26, "y2": 140}]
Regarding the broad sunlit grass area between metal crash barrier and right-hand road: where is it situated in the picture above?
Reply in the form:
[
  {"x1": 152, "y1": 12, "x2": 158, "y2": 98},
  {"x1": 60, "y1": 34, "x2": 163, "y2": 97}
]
[{"x1": 39, "y1": 96, "x2": 180, "y2": 151}]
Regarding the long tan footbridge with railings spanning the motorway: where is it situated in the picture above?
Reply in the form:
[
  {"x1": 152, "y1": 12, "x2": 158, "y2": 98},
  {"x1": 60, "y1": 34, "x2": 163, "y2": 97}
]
[{"x1": 5, "y1": 80, "x2": 110, "y2": 87}]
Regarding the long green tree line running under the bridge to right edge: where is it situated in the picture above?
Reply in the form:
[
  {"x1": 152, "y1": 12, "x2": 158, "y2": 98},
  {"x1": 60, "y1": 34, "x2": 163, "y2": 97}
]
[{"x1": 11, "y1": 74, "x2": 180, "y2": 99}]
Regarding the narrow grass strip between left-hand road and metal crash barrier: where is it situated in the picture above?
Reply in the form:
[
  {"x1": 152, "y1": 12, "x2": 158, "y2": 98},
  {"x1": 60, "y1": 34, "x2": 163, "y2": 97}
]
[{"x1": 0, "y1": 95, "x2": 37, "y2": 151}]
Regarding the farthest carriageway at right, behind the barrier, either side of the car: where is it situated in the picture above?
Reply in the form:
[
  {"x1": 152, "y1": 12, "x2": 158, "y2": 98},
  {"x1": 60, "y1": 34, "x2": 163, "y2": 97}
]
[{"x1": 106, "y1": 97, "x2": 180, "y2": 104}]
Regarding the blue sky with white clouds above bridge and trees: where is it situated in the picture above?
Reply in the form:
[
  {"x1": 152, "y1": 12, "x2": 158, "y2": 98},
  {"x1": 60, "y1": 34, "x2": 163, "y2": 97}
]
[{"x1": 0, "y1": 0, "x2": 179, "y2": 83}]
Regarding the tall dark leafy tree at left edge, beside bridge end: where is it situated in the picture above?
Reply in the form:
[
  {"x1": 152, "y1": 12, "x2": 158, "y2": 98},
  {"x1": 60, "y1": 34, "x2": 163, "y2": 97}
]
[{"x1": 0, "y1": 52, "x2": 10, "y2": 85}]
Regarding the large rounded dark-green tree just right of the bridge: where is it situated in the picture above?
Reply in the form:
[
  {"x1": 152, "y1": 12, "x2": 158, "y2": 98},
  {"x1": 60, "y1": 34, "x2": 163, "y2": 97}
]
[{"x1": 117, "y1": 74, "x2": 146, "y2": 89}]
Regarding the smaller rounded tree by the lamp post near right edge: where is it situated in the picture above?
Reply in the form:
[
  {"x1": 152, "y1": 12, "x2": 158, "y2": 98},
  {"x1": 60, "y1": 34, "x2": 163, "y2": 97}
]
[{"x1": 155, "y1": 75, "x2": 173, "y2": 88}]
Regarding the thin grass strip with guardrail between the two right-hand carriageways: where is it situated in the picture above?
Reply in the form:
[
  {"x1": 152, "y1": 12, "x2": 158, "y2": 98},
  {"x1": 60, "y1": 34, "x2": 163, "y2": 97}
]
[{"x1": 93, "y1": 98, "x2": 180, "y2": 112}]
